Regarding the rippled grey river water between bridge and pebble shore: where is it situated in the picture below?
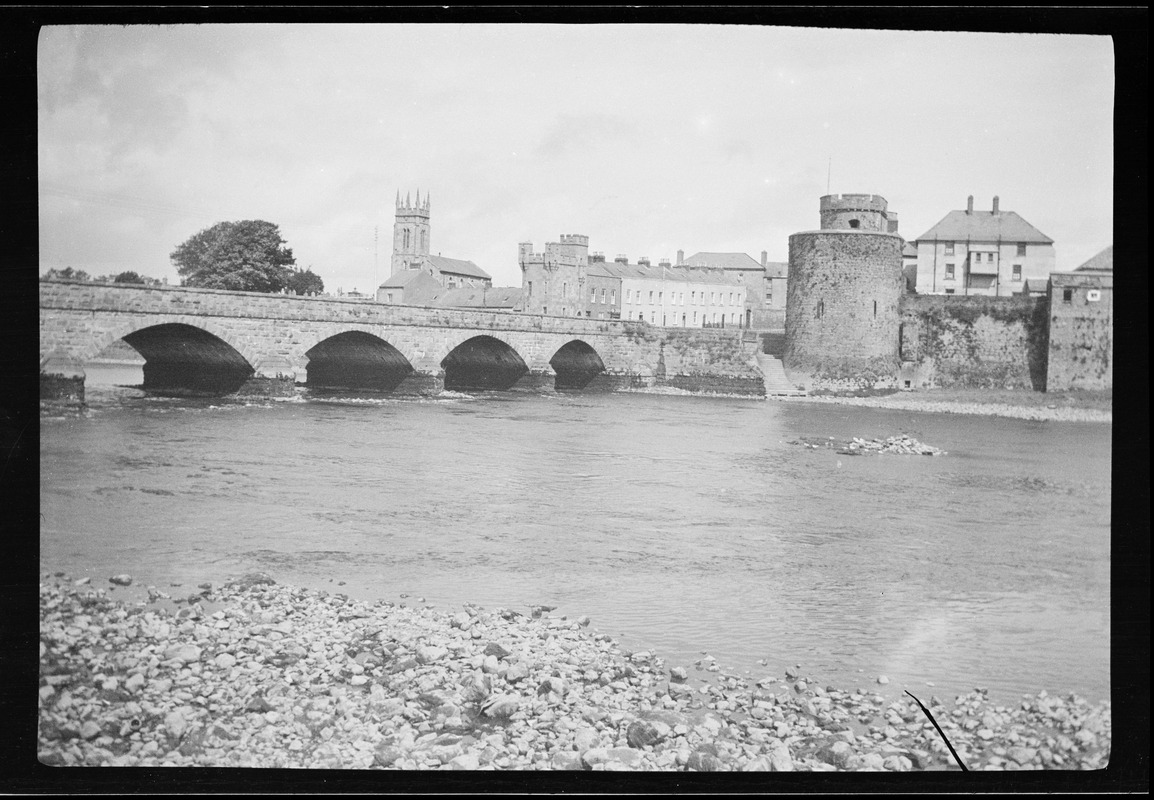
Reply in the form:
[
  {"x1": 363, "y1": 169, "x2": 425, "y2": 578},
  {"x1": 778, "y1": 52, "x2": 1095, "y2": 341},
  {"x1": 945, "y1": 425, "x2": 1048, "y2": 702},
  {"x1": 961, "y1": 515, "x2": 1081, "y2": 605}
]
[{"x1": 40, "y1": 367, "x2": 1110, "y2": 702}]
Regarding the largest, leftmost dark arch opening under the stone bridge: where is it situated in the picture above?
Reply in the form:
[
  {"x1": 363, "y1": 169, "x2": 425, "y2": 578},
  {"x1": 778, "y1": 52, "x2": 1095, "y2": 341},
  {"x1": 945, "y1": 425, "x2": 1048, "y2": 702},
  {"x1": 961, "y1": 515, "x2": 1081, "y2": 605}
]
[{"x1": 120, "y1": 322, "x2": 255, "y2": 397}]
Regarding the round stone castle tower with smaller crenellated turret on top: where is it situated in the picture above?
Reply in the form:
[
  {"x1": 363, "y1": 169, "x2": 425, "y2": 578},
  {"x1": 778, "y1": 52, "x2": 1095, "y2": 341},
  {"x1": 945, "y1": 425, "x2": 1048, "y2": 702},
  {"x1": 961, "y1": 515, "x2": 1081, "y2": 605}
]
[{"x1": 784, "y1": 194, "x2": 904, "y2": 391}]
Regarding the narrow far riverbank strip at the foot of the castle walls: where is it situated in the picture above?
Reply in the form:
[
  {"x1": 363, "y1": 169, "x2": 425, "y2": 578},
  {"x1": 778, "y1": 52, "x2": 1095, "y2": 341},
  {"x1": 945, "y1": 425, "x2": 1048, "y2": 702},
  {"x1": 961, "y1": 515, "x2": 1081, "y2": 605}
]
[{"x1": 772, "y1": 389, "x2": 1114, "y2": 423}]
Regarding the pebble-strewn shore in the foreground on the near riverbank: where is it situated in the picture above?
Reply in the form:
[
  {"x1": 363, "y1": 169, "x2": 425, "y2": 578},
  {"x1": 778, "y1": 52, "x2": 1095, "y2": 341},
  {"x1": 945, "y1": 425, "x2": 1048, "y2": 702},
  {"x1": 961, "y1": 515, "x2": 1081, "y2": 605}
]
[{"x1": 38, "y1": 573, "x2": 1111, "y2": 772}]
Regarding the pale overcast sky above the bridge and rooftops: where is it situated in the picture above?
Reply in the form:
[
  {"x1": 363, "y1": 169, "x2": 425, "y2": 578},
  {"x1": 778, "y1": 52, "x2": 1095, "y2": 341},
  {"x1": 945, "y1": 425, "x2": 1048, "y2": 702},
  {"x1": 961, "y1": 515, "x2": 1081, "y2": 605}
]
[{"x1": 37, "y1": 24, "x2": 1115, "y2": 292}]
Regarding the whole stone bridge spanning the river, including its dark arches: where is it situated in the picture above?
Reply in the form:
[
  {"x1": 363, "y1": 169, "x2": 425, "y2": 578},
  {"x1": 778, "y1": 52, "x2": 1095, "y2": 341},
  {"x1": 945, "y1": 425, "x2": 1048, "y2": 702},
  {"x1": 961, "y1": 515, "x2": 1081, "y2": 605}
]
[{"x1": 39, "y1": 281, "x2": 765, "y2": 399}]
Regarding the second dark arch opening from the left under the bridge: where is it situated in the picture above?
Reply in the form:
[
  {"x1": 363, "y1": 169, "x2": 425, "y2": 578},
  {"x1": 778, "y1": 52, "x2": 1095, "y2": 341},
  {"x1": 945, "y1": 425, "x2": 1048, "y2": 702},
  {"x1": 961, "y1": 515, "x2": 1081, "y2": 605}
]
[{"x1": 305, "y1": 330, "x2": 413, "y2": 391}]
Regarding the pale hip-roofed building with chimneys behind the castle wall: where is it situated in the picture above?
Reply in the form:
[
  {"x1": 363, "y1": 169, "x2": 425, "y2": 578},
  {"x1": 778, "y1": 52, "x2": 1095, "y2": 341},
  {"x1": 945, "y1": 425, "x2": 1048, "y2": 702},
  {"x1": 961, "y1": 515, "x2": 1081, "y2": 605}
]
[{"x1": 914, "y1": 195, "x2": 1055, "y2": 297}]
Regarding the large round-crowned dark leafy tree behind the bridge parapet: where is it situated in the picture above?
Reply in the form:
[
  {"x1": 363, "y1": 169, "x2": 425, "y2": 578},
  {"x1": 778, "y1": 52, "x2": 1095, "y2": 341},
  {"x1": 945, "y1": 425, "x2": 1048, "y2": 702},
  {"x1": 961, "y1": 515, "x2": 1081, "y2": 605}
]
[{"x1": 171, "y1": 219, "x2": 297, "y2": 292}]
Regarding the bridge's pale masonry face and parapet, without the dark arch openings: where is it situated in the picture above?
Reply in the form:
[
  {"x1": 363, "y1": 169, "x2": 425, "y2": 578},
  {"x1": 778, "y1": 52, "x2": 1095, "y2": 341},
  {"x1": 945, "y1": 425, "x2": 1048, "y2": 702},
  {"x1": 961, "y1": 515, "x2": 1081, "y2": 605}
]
[{"x1": 39, "y1": 281, "x2": 764, "y2": 395}]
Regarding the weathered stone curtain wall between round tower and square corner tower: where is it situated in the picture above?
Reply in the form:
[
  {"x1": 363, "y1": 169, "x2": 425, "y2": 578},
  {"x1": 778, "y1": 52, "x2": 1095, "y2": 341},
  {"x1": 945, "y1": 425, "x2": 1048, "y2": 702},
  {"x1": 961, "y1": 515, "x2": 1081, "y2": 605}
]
[{"x1": 900, "y1": 294, "x2": 1047, "y2": 391}]
